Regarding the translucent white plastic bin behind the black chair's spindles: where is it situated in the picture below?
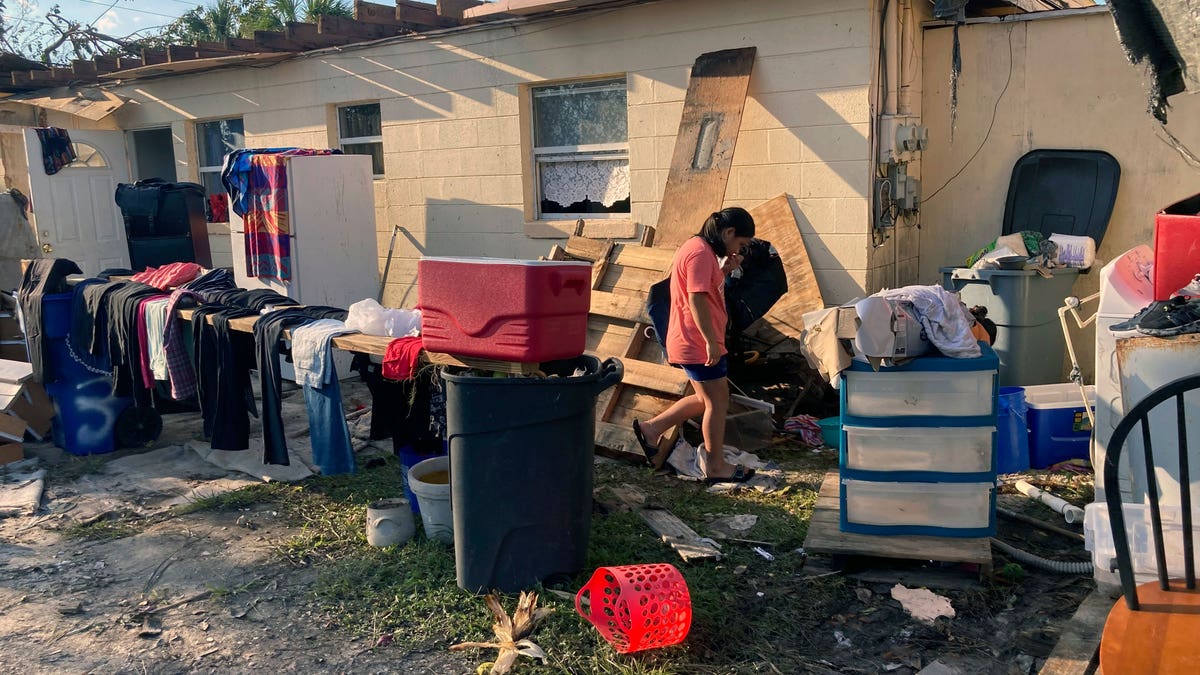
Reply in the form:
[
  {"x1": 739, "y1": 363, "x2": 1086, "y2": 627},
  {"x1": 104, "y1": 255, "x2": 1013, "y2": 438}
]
[{"x1": 1084, "y1": 503, "x2": 1200, "y2": 585}]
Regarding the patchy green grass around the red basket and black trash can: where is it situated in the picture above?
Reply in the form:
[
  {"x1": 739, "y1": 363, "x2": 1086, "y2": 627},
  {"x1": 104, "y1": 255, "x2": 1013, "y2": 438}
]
[{"x1": 169, "y1": 444, "x2": 853, "y2": 675}]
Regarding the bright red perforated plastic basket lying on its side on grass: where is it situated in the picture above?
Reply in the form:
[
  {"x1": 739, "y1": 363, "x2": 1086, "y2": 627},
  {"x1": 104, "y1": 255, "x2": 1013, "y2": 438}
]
[{"x1": 575, "y1": 563, "x2": 691, "y2": 653}]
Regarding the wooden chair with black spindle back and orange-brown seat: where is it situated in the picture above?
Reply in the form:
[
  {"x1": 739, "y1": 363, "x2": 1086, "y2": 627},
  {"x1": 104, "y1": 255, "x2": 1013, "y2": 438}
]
[{"x1": 1100, "y1": 375, "x2": 1200, "y2": 675}]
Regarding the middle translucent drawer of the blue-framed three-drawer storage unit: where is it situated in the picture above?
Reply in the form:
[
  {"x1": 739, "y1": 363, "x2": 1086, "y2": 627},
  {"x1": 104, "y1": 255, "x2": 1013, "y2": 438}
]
[{"x1": 845, "y1": 426, "x2": 996, "y2": 473}]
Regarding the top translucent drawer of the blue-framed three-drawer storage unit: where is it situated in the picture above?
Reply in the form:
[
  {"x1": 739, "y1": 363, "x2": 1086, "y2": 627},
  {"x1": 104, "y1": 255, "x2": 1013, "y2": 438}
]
[{"x1": 842, "y1": 370, "x2": 995, "y2": 417}]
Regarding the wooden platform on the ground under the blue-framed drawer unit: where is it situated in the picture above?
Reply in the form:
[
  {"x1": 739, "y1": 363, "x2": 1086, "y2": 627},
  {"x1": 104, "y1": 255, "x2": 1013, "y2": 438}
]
[{"x1": 804, "y1": 471, "x2": 991, "y2": 577}]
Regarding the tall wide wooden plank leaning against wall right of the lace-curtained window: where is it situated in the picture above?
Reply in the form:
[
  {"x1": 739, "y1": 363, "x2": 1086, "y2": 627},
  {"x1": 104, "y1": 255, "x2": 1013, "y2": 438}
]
[{"x1": 654, "y1": 47, "x2": 756, "y2": 249}]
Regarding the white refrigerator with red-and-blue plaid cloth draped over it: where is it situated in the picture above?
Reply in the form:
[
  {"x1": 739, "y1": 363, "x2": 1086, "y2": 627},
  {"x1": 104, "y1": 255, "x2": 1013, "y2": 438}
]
[{"x1": 229, "y1": 155, "x2": 379, "y2": 307}]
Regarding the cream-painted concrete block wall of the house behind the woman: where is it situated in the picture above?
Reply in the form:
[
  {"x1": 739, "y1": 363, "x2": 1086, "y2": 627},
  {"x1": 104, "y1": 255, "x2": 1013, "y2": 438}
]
[{"x1": 110, "y1": 0, "x2": 871, "y2": 305}]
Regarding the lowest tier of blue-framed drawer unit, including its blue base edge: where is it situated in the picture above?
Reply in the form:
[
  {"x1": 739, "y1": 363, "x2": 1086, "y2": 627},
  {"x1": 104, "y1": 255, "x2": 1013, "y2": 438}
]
[{"x1": 841, "y1": 478, "x2": 996, "y2": 537}]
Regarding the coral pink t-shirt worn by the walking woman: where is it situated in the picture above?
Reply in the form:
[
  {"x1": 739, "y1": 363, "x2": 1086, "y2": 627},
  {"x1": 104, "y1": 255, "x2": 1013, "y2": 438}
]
[{"x1": 667, "y1": 237, "x2": 728, "y2": 365}]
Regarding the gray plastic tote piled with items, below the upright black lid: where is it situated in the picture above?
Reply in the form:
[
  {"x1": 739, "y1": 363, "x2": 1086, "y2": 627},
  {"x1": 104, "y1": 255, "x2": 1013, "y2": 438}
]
[{"x1": 941, "y1": 267, "x2": 1079, "y2": 387}]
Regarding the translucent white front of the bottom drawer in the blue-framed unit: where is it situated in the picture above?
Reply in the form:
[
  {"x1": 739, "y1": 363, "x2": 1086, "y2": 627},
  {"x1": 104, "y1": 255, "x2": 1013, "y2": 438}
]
[{"x1": 841, "y1": 478, "x2": 995, "y2": 530}]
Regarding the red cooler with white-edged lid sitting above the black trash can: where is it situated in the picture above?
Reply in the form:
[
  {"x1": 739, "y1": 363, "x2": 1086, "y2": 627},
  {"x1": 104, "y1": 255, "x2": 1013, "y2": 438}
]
[{"x1": 416, "y1": 258, "x2": 592, "y2": 363}]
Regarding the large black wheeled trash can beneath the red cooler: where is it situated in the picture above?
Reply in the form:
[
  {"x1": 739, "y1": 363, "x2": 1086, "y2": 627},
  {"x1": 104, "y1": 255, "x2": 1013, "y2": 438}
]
[{"x1": 443, "y1": 356, "x2": 624, "y2": 593}]
